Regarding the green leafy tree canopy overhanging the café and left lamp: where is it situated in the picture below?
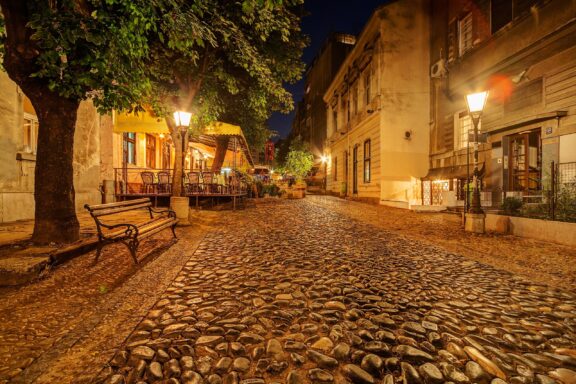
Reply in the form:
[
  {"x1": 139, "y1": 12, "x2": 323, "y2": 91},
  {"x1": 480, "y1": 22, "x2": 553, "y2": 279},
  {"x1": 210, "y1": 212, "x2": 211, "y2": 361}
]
[{"x1": 0, "y1": 0, "x2": 307, "y2": 146}]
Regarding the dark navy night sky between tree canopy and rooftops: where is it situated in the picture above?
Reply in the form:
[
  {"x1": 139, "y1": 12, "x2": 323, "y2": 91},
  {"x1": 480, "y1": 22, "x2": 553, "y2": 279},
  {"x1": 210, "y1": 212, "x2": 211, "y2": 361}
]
[{"x1": 269, "y1": 0, "x2": 387, "y2": 137}]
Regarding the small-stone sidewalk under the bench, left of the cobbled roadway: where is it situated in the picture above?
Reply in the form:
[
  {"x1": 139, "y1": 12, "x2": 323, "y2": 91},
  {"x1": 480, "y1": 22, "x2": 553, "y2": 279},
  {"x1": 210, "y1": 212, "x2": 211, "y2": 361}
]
[{"x1": 0, "y1": 212, "x2": 217, "y2": 384}]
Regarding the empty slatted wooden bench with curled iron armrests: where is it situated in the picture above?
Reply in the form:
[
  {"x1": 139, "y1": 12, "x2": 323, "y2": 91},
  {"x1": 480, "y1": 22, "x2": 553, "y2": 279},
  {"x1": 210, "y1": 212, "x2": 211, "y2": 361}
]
[{"x1": 84, "y1": 198, "x2": 178, "y2": 264}]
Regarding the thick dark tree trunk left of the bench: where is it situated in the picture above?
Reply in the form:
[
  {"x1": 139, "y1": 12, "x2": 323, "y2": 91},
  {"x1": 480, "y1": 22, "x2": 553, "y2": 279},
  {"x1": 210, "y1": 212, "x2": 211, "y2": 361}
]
[{"x1": 25, "y1": 87, "x2": 80, "y2": 244}]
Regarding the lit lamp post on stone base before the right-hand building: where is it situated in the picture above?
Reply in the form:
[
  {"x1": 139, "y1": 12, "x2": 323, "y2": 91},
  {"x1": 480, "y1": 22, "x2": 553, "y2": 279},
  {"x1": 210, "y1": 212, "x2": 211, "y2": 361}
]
[{"x1": 466, "y1": 91, "x2": 488, "y2": 233}]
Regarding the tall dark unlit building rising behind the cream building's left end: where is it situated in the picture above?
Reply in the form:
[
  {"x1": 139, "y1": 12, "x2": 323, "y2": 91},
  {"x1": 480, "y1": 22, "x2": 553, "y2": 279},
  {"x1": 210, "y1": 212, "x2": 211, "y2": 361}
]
[{"x1": 292, "y1": 33, "x2": 356, "y2": 158}]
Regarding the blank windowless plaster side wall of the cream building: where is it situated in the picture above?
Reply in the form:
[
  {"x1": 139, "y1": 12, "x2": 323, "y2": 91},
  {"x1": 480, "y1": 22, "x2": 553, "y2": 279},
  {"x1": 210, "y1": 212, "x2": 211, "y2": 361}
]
[{"x1": 379, "y1": 0, "x2": 430, "y2": 207}]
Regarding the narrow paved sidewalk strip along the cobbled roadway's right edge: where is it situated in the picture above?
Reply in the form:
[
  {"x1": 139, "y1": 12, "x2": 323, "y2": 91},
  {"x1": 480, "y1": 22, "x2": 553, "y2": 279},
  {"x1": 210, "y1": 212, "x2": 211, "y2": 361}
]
[{"x1": 306, "y1": 196, "x2": 576, "y2": 290}]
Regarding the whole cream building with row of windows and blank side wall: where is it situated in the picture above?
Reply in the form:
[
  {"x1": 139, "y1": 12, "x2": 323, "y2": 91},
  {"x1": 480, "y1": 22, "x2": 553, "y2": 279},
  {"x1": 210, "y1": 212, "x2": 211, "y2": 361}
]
[{"x1": 324, "y1": 0, "x2": 430, "y2": 208}]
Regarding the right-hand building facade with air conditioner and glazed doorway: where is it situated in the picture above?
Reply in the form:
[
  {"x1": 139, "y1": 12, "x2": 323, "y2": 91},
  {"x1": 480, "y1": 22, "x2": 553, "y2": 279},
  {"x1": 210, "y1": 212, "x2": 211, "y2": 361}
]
[{"x1": 422, "y1": 0, "x2": 576, "y2": 208}]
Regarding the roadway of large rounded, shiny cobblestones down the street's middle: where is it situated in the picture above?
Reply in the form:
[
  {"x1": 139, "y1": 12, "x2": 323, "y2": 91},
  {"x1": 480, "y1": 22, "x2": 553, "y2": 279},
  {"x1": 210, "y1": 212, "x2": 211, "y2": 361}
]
[{"x1": 99, "y1": 200, "x2": 576, "y2": 384}]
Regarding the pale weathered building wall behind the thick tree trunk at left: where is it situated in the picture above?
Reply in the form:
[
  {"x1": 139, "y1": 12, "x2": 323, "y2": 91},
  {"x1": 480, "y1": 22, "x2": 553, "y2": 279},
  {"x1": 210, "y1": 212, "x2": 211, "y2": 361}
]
[{"x1": 0, "y1": 71, "x2": 101, "y2": 223}]
